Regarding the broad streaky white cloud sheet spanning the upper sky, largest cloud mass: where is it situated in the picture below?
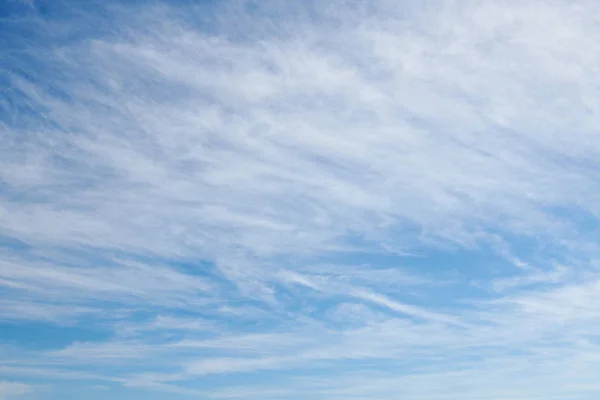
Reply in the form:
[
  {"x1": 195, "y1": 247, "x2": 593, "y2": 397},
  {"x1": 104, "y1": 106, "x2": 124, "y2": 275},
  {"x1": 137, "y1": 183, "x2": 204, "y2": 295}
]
[{"x1": 3, "y1": 3, "x2": 594, "y2": 256}]
